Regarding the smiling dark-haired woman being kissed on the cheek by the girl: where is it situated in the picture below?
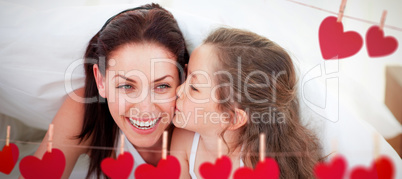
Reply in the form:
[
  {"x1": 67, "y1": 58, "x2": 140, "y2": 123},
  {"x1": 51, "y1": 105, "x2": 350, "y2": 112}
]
[{"x1": 31, "y1": 4, "x2": 189, "y2": 178}]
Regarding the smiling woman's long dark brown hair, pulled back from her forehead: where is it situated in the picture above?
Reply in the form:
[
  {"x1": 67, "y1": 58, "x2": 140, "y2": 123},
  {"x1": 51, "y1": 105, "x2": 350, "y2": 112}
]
[{"x1": 78, "y1": 4, "x2": 189, "y2": 178}]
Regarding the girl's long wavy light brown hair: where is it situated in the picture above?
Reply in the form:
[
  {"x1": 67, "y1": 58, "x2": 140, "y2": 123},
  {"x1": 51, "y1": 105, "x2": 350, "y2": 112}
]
[{"x1": 204, "y1": 28, "x2": 321, "y2": 179}]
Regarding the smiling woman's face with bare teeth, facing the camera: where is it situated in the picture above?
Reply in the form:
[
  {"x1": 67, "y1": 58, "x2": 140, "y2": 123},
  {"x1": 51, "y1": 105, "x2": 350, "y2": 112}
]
[{"x1": 94, "y1": 43, "x2": 179, "y2": 147}]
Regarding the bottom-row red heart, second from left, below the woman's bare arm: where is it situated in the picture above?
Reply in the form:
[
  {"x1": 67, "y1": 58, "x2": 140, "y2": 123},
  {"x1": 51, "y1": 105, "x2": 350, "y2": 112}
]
[{"x1": 20, "y1": 148, "x2": 66, "y2": 179}]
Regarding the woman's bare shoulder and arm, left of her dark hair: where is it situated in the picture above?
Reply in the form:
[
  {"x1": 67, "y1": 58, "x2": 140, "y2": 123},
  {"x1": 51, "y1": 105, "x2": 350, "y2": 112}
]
[{"x1": 27, "y1": 88, "x2": 91, "y2": 178}]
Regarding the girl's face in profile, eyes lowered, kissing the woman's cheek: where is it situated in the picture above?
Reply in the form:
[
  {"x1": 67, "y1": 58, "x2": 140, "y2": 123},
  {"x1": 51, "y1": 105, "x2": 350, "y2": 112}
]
[{"x1": 173, "y1": 45, "x2": 229, "y2": 133}]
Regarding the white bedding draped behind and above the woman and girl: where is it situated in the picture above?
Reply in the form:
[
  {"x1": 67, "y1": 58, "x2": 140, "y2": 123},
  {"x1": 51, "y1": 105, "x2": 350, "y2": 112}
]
[{"x1": 0, "y1": 0, "x2": 402, "y2": 178}]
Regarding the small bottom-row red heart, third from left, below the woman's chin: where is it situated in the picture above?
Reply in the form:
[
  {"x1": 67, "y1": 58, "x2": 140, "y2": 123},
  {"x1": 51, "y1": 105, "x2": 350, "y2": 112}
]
[{"x1": 101, "y1": 152, "x2": 134, "y2": 179}]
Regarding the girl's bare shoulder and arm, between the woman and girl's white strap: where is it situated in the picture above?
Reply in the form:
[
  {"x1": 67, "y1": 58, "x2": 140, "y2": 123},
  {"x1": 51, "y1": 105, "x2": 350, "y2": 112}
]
[{"x1": 170, "y1": 128, "x2": 194, "y2": 179}]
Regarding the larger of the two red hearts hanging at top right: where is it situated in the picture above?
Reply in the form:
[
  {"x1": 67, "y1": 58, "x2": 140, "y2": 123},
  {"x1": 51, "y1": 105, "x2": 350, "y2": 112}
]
[{"x1": 319, "y1": 16, "x2": 363, "y2": 60}]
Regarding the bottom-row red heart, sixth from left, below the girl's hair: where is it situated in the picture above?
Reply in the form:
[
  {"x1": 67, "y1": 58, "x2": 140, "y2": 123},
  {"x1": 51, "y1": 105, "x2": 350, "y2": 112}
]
[{"x1": 233, "y1": 158, "x2": 279, "y2": 179}]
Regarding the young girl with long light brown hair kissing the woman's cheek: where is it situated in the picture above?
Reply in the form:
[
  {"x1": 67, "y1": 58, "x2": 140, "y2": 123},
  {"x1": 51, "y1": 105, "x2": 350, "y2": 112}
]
[{"x1": 171, "y1": 28, "x2": 321, "y2": 179}]
